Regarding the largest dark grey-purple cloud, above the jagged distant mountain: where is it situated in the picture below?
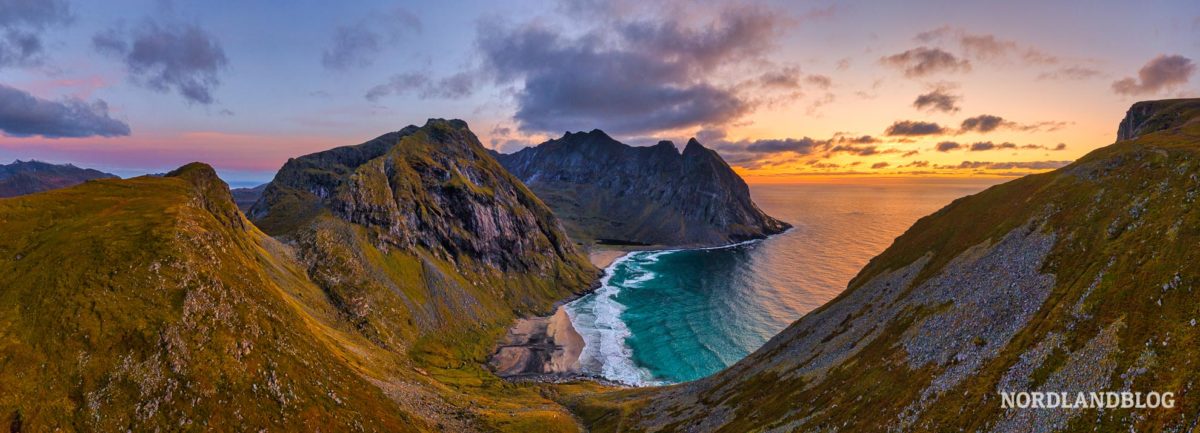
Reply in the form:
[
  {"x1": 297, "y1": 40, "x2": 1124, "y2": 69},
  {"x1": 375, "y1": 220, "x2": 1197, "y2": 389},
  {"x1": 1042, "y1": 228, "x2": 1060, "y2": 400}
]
[{"x1": 478, "y1": 7, "x2": 786, "y2": 134}]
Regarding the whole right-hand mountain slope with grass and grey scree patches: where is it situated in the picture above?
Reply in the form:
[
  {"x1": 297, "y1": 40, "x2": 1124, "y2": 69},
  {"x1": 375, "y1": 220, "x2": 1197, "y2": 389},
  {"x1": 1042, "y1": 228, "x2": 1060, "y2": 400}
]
[{"x1": 569, "y1": 100, "x2": 1200, "y2": 432}]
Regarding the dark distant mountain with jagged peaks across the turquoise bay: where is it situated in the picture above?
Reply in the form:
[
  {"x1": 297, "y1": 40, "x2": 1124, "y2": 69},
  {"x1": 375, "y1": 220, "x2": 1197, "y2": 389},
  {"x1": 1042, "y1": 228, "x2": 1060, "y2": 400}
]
[{"x1": 496, "y1": 130, "x2": 791, "y2": 246}]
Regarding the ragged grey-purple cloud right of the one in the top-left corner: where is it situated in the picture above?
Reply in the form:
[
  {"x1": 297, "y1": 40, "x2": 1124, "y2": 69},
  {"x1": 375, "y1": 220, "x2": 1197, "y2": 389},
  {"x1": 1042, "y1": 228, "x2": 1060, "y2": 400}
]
[{"x1": 92, "y1": 22, "x2": 229, "y2": 104}]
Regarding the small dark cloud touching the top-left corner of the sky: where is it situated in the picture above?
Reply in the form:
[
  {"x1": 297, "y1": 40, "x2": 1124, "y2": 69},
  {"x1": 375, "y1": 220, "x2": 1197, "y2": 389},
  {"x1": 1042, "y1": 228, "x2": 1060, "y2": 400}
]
[{"x1": 0, "y1": 0, "x2": 72, "y2": 68}]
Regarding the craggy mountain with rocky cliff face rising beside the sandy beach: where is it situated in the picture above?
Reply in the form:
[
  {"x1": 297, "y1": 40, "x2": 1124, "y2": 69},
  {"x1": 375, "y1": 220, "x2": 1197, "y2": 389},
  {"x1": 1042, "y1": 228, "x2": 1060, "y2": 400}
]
[{"x1": 248, "y1": 120, "x2": 599, "y2": 431}]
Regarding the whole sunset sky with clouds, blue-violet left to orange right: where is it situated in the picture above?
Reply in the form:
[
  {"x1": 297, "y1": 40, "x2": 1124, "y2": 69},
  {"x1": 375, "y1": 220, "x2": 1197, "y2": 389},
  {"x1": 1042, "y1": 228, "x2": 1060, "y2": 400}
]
[{"x1": 0, "y1": 0, "x2": 1200, "y2": 186}]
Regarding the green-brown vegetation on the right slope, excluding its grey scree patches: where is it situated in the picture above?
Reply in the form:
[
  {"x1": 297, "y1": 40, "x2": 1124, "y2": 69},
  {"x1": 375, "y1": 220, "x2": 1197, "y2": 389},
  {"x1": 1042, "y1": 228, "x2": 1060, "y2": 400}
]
[{"x1": 565, "y1": 101, "x2": 1200, "y2": 432}]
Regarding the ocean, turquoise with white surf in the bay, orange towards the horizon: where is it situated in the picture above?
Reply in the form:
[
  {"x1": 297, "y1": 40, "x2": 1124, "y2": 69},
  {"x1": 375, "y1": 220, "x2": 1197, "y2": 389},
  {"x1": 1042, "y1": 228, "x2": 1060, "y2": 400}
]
[{"x1": 566, "y1": 179, "x2": 1002, "y2": 386}]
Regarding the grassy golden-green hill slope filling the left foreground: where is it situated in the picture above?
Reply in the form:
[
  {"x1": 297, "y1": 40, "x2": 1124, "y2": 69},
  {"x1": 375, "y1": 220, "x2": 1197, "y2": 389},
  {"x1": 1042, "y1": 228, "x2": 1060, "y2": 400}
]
[{"x1": 0, "y1": 164, "x2": 437, "y2": 432}]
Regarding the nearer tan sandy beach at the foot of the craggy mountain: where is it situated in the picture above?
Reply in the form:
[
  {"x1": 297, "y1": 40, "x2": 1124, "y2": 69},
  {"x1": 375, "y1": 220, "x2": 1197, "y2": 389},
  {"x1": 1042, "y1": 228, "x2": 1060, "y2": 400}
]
[{"x1": 488, "y1": 307, "x2": 583, "y2": 377}]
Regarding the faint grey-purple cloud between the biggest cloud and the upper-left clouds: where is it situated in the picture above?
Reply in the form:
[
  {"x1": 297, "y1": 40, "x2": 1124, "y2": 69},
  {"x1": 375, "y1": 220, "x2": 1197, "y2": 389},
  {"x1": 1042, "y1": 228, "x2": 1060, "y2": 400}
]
[{"x1": 320, "y1": 8, "x2": 421, "y2": 71}]
